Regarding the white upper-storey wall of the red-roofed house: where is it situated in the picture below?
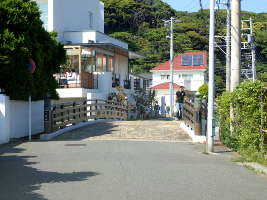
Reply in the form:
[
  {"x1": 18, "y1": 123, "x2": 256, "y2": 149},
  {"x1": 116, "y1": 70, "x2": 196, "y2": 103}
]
[{"x1": 152, "y1": 71, "x2": 205, "y2": 91}]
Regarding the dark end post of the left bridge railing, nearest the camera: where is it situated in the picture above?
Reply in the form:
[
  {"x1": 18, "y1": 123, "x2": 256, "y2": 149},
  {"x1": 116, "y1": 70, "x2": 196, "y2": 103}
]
[{"x1": 44, "y1": 99, "x2": 53, "y2": 133}]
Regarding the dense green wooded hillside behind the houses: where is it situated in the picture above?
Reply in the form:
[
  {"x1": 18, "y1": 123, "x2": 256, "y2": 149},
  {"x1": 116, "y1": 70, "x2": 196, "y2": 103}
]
[{"x1": 103, "y1": 0, "x2": 267, "y2": 90}]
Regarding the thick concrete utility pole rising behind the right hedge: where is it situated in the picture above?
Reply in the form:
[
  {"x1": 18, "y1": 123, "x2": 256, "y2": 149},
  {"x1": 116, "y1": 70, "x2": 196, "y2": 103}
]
[{"x1": 230, "y1": 0, "x2": 241, "y2": 92}]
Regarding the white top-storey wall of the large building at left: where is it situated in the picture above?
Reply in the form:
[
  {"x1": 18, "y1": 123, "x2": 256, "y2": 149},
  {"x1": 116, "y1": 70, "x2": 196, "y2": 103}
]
[{"x1": 35, "y1": 0, "x2": 104, "y2": 41}]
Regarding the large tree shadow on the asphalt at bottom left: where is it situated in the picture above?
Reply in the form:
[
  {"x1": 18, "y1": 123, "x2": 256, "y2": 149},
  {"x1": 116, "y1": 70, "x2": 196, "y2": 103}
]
[{"x1": 0, "y1": 146, "x2": 98, "y2": 200}]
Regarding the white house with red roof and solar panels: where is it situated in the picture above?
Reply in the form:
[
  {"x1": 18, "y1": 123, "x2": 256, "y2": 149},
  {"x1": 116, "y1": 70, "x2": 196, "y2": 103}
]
[{"x1": 150, "y1": 51, "x2": 208, "y2": 111}]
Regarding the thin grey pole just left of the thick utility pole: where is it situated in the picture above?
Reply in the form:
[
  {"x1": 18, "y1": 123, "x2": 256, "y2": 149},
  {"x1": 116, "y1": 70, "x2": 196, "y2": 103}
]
[{"x1": 226, "y1": 0, "x2": 231, "y2": 91}]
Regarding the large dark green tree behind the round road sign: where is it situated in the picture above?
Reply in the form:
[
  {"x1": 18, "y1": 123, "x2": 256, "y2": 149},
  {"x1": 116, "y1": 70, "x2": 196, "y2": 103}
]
[{"x1": 0, "y1": 0, "x2": 66, "y2": 100}]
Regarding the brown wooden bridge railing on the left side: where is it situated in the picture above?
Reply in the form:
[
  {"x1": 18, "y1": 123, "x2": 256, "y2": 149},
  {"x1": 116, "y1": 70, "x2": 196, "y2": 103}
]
[{"x1": 44, "y1": 99, "x2": 128, "y2": 133}]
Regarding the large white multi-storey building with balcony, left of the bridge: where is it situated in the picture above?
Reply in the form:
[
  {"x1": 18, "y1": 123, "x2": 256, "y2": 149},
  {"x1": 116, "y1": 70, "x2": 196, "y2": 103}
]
[{"x1": 35, "y1": 0, "x2": 138, "y2": 99}]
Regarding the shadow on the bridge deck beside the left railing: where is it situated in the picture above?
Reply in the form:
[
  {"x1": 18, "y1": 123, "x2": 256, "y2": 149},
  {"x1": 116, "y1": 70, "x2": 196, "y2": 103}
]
[{"x1": 54, "y1": 122, "x2": 118, "y2": 141}]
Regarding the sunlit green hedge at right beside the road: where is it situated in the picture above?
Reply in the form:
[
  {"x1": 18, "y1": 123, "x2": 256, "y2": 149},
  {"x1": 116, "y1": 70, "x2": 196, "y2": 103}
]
[{"x1": 217, "y1": 81, "x2": 263, "y2": 152}]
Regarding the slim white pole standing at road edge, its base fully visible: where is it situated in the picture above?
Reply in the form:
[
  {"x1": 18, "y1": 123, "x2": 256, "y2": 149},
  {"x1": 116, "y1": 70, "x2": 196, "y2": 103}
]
[{"x1": 206, "y1": 0, "x2": 215, "y2": 153}]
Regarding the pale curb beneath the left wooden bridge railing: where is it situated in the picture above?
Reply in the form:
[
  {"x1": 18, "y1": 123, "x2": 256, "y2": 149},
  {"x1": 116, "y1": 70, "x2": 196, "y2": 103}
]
[{"x1": 40, "y1": 119, "x2": 114, "y2": 141}]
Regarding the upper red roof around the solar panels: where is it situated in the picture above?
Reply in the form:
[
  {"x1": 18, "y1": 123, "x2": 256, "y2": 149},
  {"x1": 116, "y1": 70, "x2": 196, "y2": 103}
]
[{"x1": 151, "y1": 51, "x2": 208, "y2": 71}]
